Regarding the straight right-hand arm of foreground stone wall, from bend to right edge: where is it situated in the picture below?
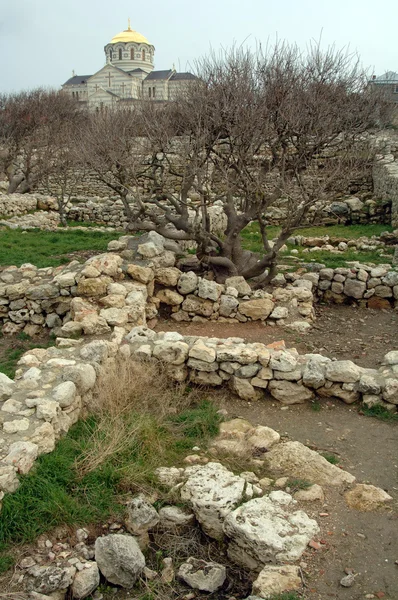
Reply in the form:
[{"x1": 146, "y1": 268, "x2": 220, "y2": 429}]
[{"x1": 126, "y1": 327, "x2": 398, "y2": 411}]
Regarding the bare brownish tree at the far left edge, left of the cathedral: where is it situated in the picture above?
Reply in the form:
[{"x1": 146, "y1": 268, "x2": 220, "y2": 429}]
[{"x1": 0, "y1": 89, "x2": 79, "y2": 193}]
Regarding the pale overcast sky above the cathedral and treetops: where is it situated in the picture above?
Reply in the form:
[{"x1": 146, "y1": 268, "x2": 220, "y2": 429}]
[{"x1": 0, "y1": 0, "x2": 398, "y2": 91}]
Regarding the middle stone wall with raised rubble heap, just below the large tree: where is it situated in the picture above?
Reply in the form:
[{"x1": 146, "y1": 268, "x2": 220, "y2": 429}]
[{"x1": 0, "y1": 232, "x2": 314, "y2": 336}]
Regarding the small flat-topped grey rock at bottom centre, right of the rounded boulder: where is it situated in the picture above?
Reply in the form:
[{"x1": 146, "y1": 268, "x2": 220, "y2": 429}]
[{"x1": 178, "y1": 556, "x2": 227, "y2": 593}]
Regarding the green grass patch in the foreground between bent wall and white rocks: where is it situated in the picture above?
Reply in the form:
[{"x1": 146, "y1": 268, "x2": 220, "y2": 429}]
[{"x1": 0, "y1": 400, "x2": 220, "y2": 572}]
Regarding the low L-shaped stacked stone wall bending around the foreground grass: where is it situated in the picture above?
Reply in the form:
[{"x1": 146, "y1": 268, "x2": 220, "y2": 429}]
[{"x1": 0, "y1": 327, "x2": 398, "y2": 500}]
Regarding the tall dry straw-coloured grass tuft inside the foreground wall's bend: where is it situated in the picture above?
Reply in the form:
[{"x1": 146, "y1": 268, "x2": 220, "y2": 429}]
[{"x1": 75, "y1": 361, "x2": 208, "y2": 488}]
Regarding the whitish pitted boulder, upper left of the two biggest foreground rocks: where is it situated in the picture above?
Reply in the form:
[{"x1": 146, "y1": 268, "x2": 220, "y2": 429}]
[{"x1": 181, "y1": 462, "x2": 246, "y2": 539}]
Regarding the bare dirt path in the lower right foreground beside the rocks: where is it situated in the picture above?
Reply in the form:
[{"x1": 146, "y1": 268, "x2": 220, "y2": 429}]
[{"x1": 221, "y1": 397, "x2": 398, "y2": 600}]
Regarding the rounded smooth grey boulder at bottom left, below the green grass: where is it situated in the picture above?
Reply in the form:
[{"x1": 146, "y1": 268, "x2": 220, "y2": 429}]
[{"x1": 95, "y1": 534, "x2": 145, "y2": 589}]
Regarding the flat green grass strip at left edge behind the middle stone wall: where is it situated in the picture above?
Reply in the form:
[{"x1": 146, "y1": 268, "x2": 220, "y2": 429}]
[{"x1": 0, "y1": 229, "x2": 122, "y2": 267}]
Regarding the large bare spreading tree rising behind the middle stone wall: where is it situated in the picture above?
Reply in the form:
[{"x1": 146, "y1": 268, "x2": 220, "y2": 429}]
[{"x1": 81, "y1": 44, "x2": 392, "y2": 285}]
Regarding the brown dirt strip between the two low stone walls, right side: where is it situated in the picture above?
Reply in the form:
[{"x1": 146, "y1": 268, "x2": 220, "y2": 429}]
[{"x1": 155, "y1": 305, "x2": 398, "y2": 370}]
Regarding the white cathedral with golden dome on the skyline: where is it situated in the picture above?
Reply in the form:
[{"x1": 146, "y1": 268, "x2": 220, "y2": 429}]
[{"x1": 62, "y1": 19, "x2": 196, "y2": 110}]
